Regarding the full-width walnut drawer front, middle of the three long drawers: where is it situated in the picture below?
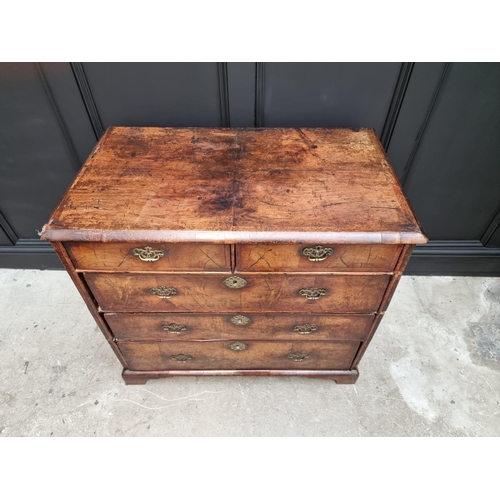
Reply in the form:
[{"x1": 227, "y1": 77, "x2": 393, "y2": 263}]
[{"x1": 105, "y1": 313, "x2": 374, "y2": 341}]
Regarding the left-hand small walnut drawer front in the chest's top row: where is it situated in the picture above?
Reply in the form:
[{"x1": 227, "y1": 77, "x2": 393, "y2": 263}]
[{"x1": 66, "y1": 242, "x2": 231, "y2": 272}]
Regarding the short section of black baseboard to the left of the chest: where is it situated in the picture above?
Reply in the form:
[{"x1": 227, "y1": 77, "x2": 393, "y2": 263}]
[{"x1": 0, "y1": 239, "x2": 63, "y2": 269}]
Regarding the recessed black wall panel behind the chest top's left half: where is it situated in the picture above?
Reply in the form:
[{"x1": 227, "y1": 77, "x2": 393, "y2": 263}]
[{"x1": 83, "y1": 63, "x2": 221, "y2": 128}]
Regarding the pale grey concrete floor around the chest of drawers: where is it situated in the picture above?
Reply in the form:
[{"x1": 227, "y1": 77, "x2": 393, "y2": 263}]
[{"x1": 0, "y1": 269, "x2": 500, "y2": 436}]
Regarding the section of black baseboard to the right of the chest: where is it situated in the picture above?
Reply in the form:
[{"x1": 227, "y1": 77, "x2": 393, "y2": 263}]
[{"x1": 405, "y1": 240, "x2": 500, "y2": 276}]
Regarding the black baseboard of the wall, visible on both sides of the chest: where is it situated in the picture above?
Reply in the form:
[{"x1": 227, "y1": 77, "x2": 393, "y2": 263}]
[{"x1": 0, "y1": 239, "x2": 500, "y2": 276}]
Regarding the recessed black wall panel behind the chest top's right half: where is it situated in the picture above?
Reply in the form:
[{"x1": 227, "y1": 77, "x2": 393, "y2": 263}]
[{"x1": 264, "y1": 63, "x2": 401, "y2": 135}]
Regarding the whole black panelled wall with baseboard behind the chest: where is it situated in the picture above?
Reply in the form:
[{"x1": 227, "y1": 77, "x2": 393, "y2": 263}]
[{"x1": 0, "y1": 63, "x2": 500, "y2": 276}]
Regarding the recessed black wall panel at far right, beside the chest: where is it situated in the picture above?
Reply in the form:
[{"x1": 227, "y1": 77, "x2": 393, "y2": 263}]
[{"x1": 405, "y1": 63, "x2": 500, "y2": 240}]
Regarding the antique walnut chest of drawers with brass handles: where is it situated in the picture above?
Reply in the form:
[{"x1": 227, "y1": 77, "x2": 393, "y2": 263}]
[{"x1": 42, "y1": 127, "x2": 427, "y2": 384}]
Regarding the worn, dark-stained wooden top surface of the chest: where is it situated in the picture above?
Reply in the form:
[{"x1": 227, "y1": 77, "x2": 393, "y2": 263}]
[{"x1": 42, "y1": 127, "x2": 427, "y2": 244}]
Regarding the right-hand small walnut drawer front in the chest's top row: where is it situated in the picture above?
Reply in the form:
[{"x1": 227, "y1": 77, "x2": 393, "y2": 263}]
[{"x1": 236, "y1": 244, "x2": 402, "y2": 272}]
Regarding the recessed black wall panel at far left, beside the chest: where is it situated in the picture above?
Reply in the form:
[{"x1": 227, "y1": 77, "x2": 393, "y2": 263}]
[{"x1": 0, "y1": 63, "x2": 80, "y2": 238}]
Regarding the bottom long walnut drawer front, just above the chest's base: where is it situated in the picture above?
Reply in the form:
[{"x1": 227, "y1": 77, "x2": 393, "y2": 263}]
[{"x1": 118, "y1": 341, "x2": 359, "y2": 370}]
